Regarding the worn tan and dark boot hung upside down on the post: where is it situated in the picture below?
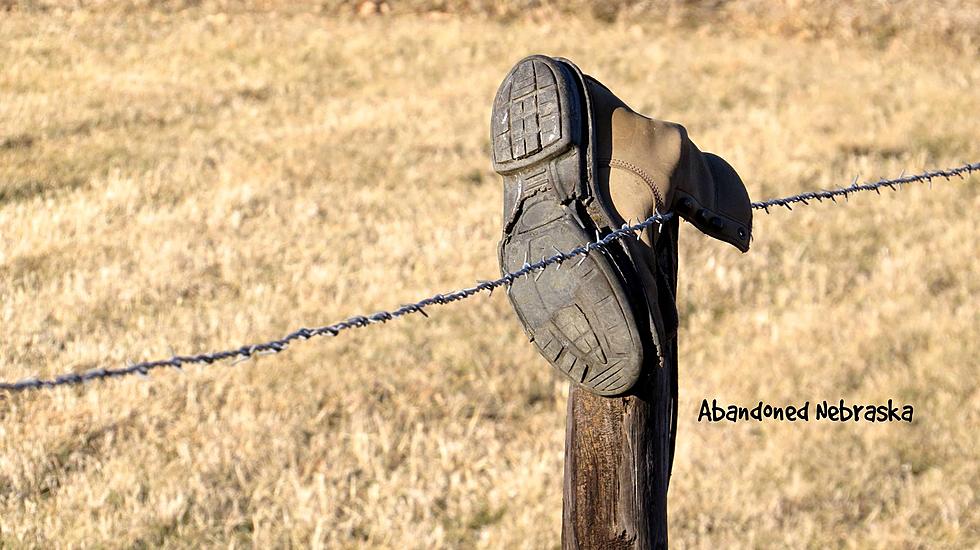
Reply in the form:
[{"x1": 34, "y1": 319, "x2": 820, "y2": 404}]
[{"x1": 491, "y1": 55, "x2": 752, "y2": 395}]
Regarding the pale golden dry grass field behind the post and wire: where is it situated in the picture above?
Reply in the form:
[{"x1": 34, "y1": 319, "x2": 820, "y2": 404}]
[{"x1": 0, "y1": 4, "x2": 980, "y2": 548}]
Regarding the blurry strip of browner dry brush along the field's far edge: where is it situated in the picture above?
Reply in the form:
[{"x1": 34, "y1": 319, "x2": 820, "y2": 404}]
[{"x1": 0, "y1": 0, "x2": 980, "y2": 55}]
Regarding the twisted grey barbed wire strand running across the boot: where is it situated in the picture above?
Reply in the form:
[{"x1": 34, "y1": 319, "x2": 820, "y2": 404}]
[{"x1": 0, "y1": 162, "x2": 980, "y2": 393}]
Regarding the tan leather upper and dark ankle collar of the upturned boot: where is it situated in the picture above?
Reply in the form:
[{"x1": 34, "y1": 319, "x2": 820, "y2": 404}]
[{"x1": 585, "y1": 77, "x2": 752, "y2": 252}]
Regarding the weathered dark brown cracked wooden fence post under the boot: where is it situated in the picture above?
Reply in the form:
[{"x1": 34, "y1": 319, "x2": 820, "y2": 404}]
[{"x1": 561, "y1": 220, "x2": 677, "y2": 550}]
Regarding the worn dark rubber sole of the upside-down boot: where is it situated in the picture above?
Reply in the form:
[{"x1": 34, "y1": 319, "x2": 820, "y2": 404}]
[{"x1": 491, "y1": 56, "x2": 643, "y2": 396}]
